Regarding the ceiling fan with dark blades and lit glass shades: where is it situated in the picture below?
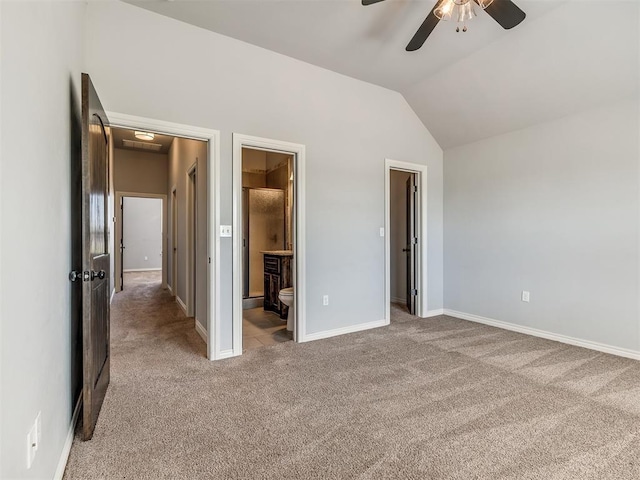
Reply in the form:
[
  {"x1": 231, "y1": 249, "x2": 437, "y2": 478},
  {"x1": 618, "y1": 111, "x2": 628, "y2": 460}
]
[{"x1": 362, "y1": 0, "x2": 526, "y2": 52}]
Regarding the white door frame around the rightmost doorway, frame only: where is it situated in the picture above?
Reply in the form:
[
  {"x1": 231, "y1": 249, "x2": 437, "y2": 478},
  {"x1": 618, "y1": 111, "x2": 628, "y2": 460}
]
[{"x1": 384, "y1": 158, "x2": 429, "y2": 325}]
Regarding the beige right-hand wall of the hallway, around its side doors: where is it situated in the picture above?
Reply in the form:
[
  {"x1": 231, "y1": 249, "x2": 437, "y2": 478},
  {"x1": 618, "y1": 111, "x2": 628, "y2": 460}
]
[{"x1": 167, "y1": 138, "x2": 209, "y2": 330}]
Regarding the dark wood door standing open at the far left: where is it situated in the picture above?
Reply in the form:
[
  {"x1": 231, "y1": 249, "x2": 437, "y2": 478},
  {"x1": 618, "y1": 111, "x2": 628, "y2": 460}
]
[{"x1": 82, "y1": 73, "x2": 110, "y2": 440}]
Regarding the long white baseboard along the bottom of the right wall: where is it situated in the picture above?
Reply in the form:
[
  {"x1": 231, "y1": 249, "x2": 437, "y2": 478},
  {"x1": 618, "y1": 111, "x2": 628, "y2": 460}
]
[{"x1": 444, "y1": 308, "x2": 640, "y2": 360}]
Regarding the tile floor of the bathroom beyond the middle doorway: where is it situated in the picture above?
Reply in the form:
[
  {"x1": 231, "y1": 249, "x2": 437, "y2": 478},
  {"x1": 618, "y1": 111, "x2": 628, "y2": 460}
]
[{"x1": 242, "y1": 307, "x2": 291, "y2": 350}]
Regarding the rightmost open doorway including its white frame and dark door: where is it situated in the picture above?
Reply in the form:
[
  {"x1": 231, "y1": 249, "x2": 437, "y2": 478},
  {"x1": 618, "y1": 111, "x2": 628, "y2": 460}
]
[{"x1": 385, "y1": 159, "x2": 427, "y2": 323}]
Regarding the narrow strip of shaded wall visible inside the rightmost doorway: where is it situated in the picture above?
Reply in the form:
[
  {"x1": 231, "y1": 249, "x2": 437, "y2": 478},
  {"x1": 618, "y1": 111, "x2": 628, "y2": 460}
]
[{"x1": 389, "y1": 170, "x2": 412, "y2": 304}]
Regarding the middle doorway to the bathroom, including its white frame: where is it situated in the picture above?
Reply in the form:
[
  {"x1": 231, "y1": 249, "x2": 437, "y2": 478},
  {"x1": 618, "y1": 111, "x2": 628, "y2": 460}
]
[{"x1": 233, "y1": 134, "x2": 304, "y2": 355}]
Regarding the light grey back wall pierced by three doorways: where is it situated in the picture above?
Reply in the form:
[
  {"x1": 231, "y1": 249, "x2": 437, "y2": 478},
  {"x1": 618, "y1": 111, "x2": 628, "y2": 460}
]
[{"x1": 86, "y1": 2, "x2": 443, "y2": 350}]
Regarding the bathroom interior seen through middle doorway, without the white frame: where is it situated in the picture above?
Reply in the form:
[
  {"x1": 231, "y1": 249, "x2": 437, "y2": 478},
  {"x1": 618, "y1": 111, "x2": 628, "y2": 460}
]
[{"x1": 241, "y1": 148, "x2": 295, "y2": 350}]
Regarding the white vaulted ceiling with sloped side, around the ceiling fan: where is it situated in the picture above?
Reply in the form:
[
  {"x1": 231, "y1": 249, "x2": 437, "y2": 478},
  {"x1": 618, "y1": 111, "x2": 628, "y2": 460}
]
[{"x1": 127, "y1": 0, "x2": 640, "y2": 149}]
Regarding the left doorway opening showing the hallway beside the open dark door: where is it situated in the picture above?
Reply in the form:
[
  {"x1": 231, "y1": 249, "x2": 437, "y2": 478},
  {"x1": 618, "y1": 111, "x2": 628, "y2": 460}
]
[{"x1": 110, "y1": 127, "x2": 210, "y2": 355}]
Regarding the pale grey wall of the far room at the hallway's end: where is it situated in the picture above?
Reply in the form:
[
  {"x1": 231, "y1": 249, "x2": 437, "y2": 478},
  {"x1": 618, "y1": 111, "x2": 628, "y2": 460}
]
[{"x1": 122, "y1": 197, "x2": 162, "y2": 272}]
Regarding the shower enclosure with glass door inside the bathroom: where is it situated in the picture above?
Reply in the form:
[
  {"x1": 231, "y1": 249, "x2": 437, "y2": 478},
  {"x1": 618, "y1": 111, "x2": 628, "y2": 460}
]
[{"x1": 242, "y1": 188, "x2": 286, "y2": 298}]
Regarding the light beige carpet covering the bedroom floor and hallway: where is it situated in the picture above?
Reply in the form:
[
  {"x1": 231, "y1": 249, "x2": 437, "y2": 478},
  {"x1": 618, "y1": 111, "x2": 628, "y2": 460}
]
[{"x1": 65, "y1": 279, "x2": 640, "y2": 480}]
